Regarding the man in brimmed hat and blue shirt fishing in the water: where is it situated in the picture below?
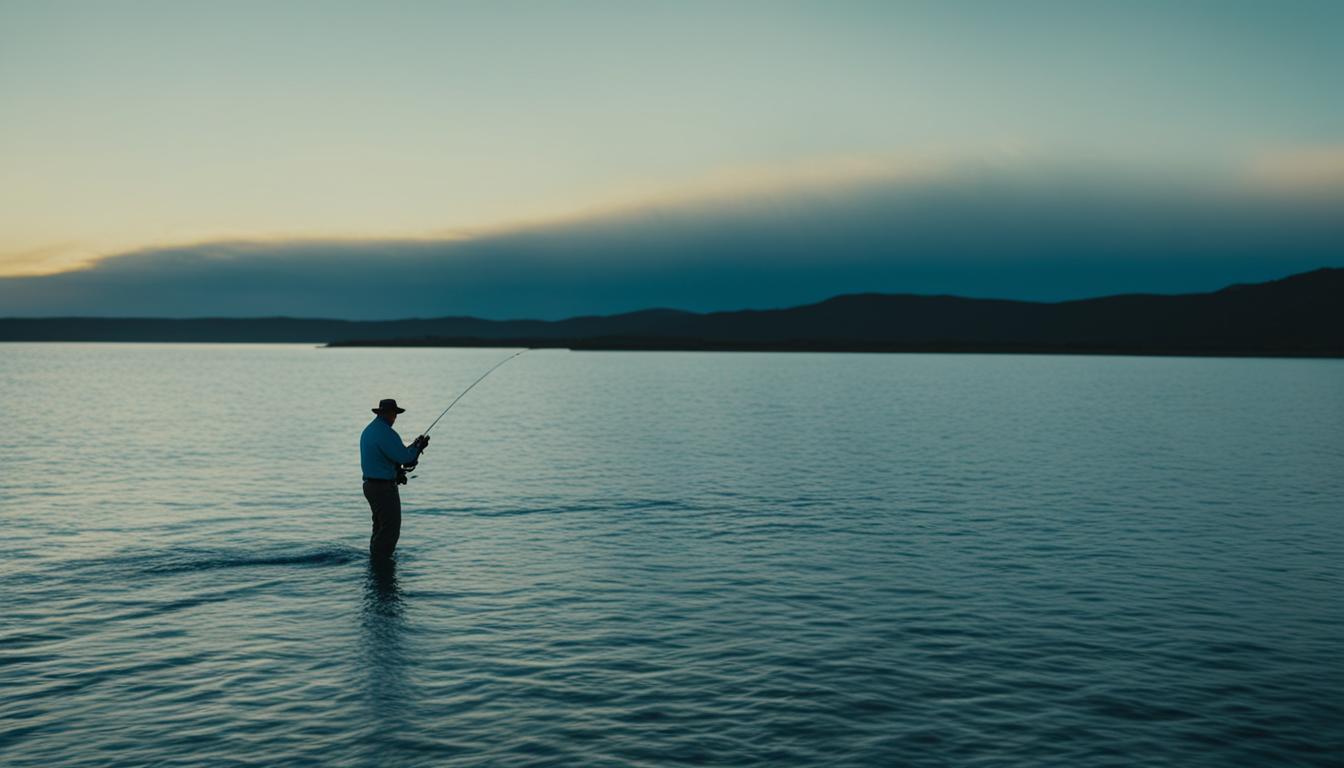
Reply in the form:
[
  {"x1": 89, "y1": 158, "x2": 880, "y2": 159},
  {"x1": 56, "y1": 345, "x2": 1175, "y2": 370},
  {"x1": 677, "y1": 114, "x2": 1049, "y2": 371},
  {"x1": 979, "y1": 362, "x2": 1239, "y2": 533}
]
[{"x1": 359, "y1": 399, "x2": 429, "y2": 560}]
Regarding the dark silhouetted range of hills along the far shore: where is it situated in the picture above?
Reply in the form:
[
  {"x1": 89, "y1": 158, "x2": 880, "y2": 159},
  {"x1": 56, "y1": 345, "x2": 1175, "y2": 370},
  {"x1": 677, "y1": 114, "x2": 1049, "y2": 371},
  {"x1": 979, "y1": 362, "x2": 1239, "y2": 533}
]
[{"x1": 0, "y1": 269, "x2": 1344, "y2": 356}]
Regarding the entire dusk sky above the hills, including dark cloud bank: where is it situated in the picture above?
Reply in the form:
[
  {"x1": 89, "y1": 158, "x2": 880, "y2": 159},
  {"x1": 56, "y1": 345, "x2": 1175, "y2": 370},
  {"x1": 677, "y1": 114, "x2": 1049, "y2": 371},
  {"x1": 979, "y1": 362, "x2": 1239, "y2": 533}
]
[{"x1": 0, "y1": 0, "x2": 1344, "y2": 317}]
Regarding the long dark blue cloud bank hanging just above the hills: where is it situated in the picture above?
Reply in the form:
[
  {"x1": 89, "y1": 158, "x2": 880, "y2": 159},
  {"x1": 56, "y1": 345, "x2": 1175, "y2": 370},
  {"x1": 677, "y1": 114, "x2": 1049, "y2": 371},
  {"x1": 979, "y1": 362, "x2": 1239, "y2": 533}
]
[{"x1": 0, "y1": 161, "x2": 1344, "y2": 319}]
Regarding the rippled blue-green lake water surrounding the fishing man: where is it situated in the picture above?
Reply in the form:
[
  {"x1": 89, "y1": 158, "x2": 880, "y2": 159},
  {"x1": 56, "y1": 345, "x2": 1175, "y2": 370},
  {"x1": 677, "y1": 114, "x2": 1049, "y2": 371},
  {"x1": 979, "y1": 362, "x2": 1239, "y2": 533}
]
[{"x1": 0, "y1": 344, "x2": 1344, "y2": 767}]
